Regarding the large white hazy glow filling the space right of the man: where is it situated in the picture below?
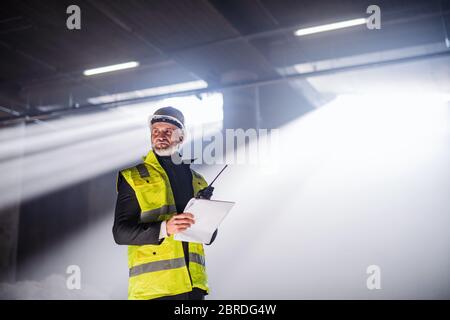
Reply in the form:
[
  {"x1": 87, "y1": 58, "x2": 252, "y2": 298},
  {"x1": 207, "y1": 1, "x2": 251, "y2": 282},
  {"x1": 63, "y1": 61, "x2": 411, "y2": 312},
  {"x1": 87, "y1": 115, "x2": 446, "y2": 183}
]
[{"x1": 202, "y1": 90, "x2": 450, "y2": 299}]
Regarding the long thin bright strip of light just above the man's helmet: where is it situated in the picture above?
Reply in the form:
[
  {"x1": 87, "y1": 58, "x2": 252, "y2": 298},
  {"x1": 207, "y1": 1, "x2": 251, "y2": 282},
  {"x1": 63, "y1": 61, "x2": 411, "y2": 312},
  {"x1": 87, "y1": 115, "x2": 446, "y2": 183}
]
[{"x1": 88, "y1": 80, "x2": 208, "y2": 104}]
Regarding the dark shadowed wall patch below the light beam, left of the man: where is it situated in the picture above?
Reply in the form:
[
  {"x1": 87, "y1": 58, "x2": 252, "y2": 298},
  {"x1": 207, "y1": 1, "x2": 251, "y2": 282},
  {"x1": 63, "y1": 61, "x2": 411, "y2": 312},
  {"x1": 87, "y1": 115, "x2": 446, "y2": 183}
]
[{"x1": 16, "y1": 171, "x2": 117, "y2": 280}]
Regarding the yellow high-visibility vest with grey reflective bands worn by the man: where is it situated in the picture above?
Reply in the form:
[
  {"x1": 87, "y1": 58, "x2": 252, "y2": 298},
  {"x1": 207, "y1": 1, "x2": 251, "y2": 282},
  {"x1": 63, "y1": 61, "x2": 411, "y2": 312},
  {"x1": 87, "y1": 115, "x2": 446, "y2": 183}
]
[{"x1": 120, "y1": 151, "x2": 209, "y2": 300}]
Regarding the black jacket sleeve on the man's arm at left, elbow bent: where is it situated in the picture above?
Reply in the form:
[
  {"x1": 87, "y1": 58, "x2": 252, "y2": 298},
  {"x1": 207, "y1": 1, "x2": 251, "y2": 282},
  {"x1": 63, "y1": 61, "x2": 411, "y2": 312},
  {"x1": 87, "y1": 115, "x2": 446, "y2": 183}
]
[{"x1": 112, "y1": 173, "x2": 164, "y2": 245}]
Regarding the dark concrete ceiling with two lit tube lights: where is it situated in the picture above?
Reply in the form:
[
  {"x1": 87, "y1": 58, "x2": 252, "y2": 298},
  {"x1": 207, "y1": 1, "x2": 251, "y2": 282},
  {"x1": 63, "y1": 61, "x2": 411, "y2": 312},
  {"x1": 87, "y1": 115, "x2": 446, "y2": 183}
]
[{"x1": 0, "y1": 0, "x2": 450, "y2": 119}]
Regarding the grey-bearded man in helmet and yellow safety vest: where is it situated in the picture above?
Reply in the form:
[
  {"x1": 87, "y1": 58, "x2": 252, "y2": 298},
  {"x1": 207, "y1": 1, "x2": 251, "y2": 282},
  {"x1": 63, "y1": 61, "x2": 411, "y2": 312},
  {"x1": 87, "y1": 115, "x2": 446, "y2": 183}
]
[{"x1": 113, "y1": 107, "x2": 217, "y2": 300}]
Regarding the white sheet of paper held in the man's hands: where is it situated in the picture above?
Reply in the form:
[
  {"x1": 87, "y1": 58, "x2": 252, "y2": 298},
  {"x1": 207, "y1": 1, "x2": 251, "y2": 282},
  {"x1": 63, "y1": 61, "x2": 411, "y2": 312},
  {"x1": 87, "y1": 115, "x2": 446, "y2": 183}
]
[{"x1": 174, "y1": 198, "x2": 235, "y2": 243}]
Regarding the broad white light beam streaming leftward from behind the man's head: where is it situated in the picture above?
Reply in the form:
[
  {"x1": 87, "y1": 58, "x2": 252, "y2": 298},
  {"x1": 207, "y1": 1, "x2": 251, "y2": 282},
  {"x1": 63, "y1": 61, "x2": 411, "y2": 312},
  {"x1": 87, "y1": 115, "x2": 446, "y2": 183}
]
[{"x1": 0, "y1": 93, "x2": 223, "y2": 210}]
